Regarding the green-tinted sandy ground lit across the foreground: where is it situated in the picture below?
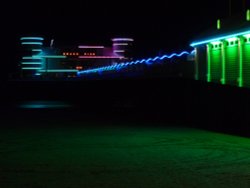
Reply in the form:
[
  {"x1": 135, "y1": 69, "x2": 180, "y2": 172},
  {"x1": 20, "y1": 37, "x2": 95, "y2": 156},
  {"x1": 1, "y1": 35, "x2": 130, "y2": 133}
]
[{"x1": 0, "y1": 122, "x2": 250, "y2": 188}]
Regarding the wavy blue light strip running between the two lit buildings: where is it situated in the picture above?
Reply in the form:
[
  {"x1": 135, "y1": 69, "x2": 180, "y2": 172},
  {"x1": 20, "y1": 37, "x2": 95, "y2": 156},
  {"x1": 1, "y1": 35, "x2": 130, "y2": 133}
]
[{"x1": 77, "y1": 51, "x2": 190, "y2": 75}]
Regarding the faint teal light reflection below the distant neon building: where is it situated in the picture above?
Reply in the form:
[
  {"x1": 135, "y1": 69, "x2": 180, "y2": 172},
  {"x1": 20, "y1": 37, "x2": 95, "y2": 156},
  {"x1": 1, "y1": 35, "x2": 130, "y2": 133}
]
[{"x1": 18, "y1": 100, "x2": 72, "y2": 109}]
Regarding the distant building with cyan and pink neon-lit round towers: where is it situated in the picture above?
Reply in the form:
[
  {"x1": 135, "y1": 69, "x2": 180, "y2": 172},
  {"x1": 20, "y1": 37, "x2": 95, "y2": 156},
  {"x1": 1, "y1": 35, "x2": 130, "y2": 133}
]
[{"x1": 20, "y1": 37, "x2": 134, "y2": 78}]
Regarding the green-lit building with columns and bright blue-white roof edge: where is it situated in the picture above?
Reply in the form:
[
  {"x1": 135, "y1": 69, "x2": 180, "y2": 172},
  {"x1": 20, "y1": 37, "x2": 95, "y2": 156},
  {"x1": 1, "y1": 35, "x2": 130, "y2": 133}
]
[{"x1": 191, "y1": 10, "x2": 250, "y2": 87}]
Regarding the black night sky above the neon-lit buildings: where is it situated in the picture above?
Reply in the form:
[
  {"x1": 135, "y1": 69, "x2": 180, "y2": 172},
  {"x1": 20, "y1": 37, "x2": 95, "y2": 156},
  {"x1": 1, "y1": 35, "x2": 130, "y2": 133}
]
[{"x1": 0, "y1": 0, "x2": 248, "y2": 78}]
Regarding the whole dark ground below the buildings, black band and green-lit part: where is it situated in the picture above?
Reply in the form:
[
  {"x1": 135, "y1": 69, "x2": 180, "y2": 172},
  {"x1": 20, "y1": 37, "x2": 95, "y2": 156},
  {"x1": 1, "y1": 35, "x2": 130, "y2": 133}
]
[{"x1": 0, "y1": 79, "x2": 250, "y2": 188}]
